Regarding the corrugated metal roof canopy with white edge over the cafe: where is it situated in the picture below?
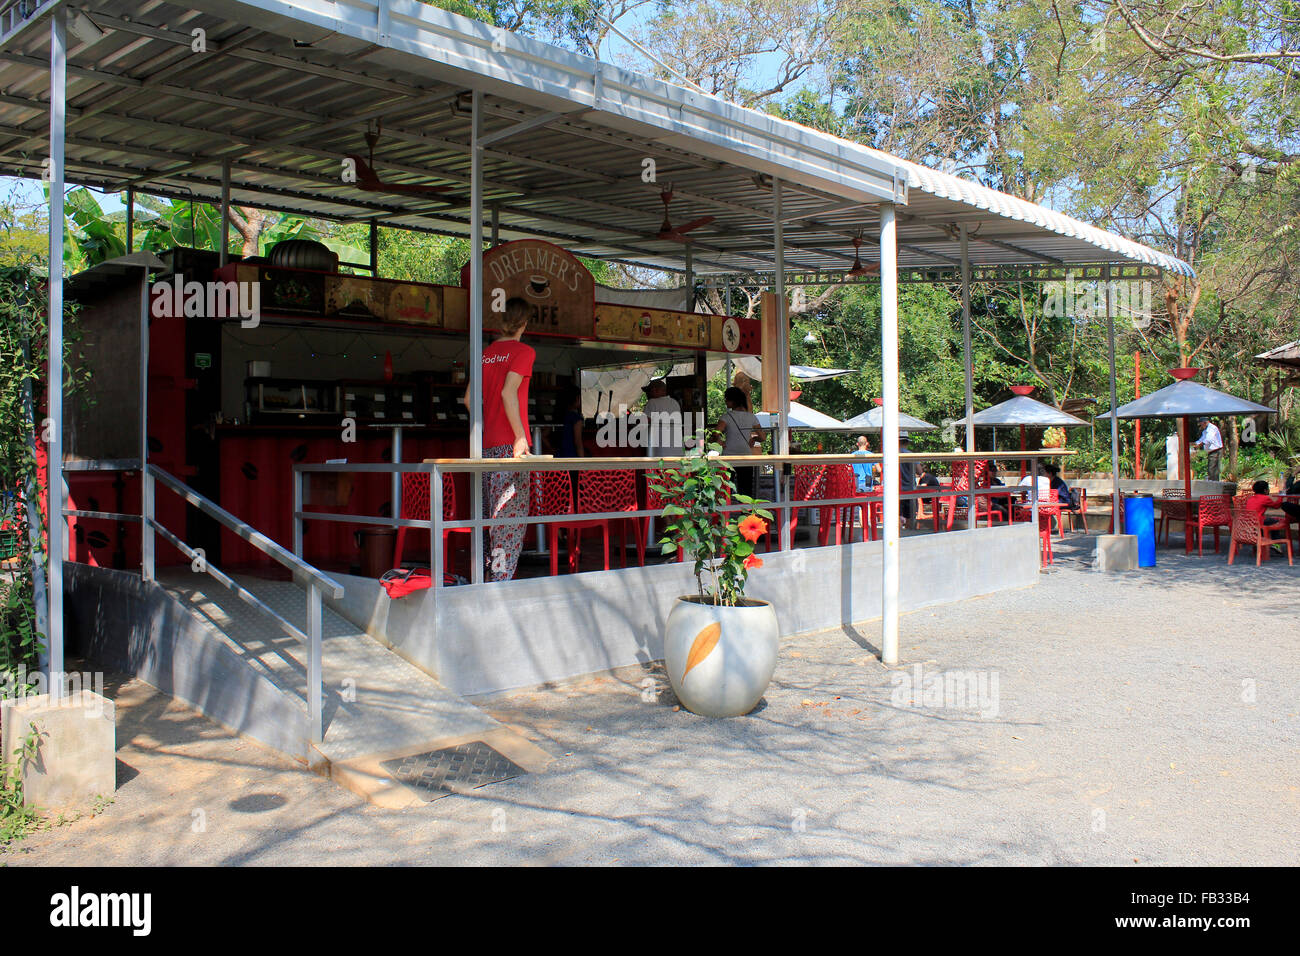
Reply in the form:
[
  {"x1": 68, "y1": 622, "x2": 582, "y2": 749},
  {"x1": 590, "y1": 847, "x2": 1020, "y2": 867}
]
[{"x1": 0, "y1": 0, "x2": 1192, "y2": 281}]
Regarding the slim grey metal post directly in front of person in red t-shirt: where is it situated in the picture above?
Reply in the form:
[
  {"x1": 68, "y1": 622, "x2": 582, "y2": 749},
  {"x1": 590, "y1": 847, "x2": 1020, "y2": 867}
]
[{"x1": 470, "y1": 90, "x2": 484, "y2": 584}]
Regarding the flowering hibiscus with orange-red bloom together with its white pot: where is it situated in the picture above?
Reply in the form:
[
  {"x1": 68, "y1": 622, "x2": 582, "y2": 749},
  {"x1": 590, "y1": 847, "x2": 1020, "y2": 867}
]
[{"x1": 651, "y1": 445, "x2": 780, "y2": 717}]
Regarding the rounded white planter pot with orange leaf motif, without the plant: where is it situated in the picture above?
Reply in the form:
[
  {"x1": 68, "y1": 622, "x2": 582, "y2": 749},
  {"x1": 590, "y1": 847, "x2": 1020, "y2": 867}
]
[{"x1": 663, "y1": 597, "x2": 780, "y2": 717}]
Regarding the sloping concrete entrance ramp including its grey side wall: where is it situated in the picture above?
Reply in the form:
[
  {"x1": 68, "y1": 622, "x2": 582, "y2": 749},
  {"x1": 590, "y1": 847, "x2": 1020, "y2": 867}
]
[{"x1": 69, "y1": 566, "x2": 550, "y2": 806}]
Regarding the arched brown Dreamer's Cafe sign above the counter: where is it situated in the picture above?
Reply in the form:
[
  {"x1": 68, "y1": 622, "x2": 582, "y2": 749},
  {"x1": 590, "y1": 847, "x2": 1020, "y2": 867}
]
[{"x1": 460, "y1": 239, "x2": 595, "y2": 338}]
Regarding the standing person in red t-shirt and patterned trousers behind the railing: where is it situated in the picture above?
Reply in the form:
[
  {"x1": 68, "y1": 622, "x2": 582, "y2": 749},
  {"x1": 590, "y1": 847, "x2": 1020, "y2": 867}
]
[{"x1": 463, "y1": 298, "x2": 537, "y2": 581}]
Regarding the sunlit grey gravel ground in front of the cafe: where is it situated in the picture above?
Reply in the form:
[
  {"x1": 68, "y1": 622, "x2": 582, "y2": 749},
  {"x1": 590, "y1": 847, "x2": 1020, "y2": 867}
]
[{"x1": 0, "y1": 537, "x2": 1300, "y2": 865}]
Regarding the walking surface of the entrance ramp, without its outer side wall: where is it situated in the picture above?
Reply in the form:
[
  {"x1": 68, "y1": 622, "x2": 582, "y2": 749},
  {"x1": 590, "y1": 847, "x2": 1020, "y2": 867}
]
[{"x1": 160, "y1": 570, "x2": 550, "y2": 806}]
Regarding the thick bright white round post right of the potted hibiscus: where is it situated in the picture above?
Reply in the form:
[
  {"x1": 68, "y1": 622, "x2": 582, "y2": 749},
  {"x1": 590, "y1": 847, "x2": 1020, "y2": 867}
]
[{"x1": 880, "y1": 203, "x2": 899, "y2": 665}]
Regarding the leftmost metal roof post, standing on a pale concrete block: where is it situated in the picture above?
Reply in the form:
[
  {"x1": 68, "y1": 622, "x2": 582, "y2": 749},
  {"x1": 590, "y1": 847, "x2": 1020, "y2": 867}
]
[{"x1": 46, "y1": 5, "x2": 68, "y2": 698}]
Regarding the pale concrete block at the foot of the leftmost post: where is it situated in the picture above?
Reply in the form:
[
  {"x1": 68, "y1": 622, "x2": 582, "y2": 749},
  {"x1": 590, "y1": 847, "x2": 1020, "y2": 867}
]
[{"x1": 0, "y1": 689, "x2": 117, "y2": 810}]
